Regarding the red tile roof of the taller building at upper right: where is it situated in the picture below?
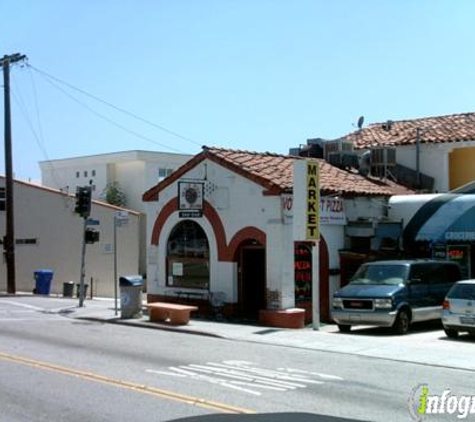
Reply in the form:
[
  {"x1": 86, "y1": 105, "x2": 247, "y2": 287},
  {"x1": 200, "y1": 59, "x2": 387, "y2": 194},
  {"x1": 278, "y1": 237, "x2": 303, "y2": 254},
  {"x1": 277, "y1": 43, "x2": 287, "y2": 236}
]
[{"x1": 342, "y1": 113, "x2": 475, "y2": 149}]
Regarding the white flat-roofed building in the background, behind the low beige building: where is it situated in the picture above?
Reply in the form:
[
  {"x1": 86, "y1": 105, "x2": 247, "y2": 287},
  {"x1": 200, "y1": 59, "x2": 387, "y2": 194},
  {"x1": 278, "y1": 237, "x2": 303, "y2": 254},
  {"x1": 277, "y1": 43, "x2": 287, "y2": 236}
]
[{"x1": 39, "y1": 150, "x2": 191, "y2": 274}]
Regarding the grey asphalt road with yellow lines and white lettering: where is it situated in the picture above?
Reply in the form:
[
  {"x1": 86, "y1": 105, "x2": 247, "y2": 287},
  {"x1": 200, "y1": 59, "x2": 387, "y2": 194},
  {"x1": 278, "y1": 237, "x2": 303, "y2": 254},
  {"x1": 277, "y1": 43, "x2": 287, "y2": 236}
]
[{"x1": 0, "y1": 297, "x2": 475, "y2": 422}]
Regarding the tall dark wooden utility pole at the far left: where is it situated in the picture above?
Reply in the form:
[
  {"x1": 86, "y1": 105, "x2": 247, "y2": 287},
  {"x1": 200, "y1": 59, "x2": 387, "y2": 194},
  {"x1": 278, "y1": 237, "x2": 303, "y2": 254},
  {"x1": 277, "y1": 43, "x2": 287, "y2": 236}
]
[{"x1": 0, "y1": 53, "x2": 26, "y2": 293}]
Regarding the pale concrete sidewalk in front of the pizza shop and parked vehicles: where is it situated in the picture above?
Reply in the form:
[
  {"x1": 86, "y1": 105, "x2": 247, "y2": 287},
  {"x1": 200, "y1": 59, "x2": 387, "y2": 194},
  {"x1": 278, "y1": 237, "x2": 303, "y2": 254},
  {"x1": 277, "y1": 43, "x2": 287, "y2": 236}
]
[{"x1": 64, "y1": 299, "x2": 475, "y2": 371}]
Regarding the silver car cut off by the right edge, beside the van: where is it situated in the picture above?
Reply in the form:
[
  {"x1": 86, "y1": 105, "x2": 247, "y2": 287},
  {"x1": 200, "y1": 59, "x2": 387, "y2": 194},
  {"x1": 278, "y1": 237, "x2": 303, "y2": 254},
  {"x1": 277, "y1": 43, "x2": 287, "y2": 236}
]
[{"x1": 442, "y1": 280, "x2": 475, "y2": 338}]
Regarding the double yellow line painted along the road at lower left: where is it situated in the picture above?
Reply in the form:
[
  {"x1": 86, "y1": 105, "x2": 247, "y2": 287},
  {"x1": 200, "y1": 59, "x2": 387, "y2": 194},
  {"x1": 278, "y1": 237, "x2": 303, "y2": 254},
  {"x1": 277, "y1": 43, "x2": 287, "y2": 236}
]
[{"x1": 0, "y1": 352, "x2": 255, "y2": 413}]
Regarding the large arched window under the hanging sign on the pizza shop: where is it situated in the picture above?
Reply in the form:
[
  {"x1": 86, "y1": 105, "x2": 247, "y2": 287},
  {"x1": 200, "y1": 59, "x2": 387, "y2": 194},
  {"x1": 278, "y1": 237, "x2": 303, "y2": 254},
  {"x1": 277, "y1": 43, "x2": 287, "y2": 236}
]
[{"x1": 167, "y1": 220, "x2": 209, "y2": 289}]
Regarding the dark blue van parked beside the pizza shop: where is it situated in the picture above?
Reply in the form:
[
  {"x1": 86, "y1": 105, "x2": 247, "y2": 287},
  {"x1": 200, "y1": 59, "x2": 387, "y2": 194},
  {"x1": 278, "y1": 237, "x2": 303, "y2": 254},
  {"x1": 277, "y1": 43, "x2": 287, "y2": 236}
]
[{"x1": 331, "y1": 260, "x2": 462, "y2": 334}]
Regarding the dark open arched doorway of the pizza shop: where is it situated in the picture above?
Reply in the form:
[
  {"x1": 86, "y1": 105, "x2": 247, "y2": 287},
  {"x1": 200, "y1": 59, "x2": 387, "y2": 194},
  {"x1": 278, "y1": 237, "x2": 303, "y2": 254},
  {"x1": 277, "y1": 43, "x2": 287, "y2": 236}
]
[{"x1": 236, "y1": 240, "x2": 266, "y2": 320}]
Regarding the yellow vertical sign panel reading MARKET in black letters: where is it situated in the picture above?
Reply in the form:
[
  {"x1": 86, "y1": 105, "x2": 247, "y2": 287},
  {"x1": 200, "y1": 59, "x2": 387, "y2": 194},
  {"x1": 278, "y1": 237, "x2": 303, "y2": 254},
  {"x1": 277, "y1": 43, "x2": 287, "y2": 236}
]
[{"x1": 306, "y1": 161, "x2": 320, "y2": 240}]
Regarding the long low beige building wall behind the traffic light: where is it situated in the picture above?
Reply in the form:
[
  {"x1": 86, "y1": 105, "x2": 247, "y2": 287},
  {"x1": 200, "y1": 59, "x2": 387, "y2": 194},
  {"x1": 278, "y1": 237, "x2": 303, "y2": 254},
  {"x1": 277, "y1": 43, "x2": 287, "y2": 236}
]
[{"x1": 0, "y1": 177, "x2": 140, "y2": 297}]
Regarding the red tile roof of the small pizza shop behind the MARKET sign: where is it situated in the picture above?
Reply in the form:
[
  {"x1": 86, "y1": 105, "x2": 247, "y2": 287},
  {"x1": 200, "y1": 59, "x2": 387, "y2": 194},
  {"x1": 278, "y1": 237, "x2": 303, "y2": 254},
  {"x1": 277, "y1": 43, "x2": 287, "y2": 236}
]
[{"x1": 143, "y1": 147, "x2": 413, "y2": 201}]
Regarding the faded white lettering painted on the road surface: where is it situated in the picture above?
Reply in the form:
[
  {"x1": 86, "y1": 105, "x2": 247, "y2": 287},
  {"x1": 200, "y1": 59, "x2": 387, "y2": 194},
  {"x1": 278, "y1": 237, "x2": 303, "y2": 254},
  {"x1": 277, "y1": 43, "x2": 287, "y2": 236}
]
[{"x1": 146, "y1": 360, "x2": 343, "y2": 396}]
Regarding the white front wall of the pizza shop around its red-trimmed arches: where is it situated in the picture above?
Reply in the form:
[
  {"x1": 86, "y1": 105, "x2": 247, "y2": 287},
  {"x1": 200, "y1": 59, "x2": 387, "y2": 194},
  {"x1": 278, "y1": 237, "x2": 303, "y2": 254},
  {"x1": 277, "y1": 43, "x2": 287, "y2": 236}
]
[{"x1": 147, "y1": 160, "x2": 293, "y2": 302}]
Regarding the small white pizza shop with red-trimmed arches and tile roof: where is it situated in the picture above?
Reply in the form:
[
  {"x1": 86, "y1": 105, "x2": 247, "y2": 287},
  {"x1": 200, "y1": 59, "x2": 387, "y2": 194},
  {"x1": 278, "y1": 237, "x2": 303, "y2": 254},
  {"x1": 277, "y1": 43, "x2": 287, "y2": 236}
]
[{"x1": 143, "y1": 147, "x2": 407, "y2": 319}]
